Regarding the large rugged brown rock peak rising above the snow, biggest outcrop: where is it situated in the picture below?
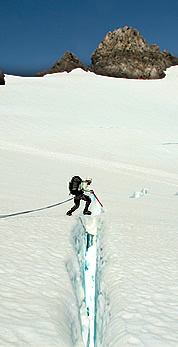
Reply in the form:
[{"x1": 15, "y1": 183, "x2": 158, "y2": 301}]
[{"x1": 88, "y1": 26, "x2": 178, "y2": 79}]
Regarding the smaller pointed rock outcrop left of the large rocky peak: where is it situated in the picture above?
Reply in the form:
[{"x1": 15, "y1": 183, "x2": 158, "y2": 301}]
[{"x1": 35, "y1": 51, "x2": 86, "y2": 77}]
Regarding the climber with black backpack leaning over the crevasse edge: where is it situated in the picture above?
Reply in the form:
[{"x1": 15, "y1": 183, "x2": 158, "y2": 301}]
[{"x1": 66, "y1": 176, "x2": 94, "y2": 216}]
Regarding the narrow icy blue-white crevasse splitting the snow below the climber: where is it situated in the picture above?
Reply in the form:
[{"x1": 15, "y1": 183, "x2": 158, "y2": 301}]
[{"x1": 68, "y1": 200, "x2": 108, "y2": 347}]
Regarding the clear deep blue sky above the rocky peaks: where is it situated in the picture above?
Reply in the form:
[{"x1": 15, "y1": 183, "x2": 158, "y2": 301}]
[{"x1": 0, "y1": 0, "x2": 178, "y2": 75}]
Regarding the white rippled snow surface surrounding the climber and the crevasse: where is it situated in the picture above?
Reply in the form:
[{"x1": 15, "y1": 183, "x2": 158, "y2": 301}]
[{"x1": 0, "y1": 66, "x2": 178, "y2": 347}]
